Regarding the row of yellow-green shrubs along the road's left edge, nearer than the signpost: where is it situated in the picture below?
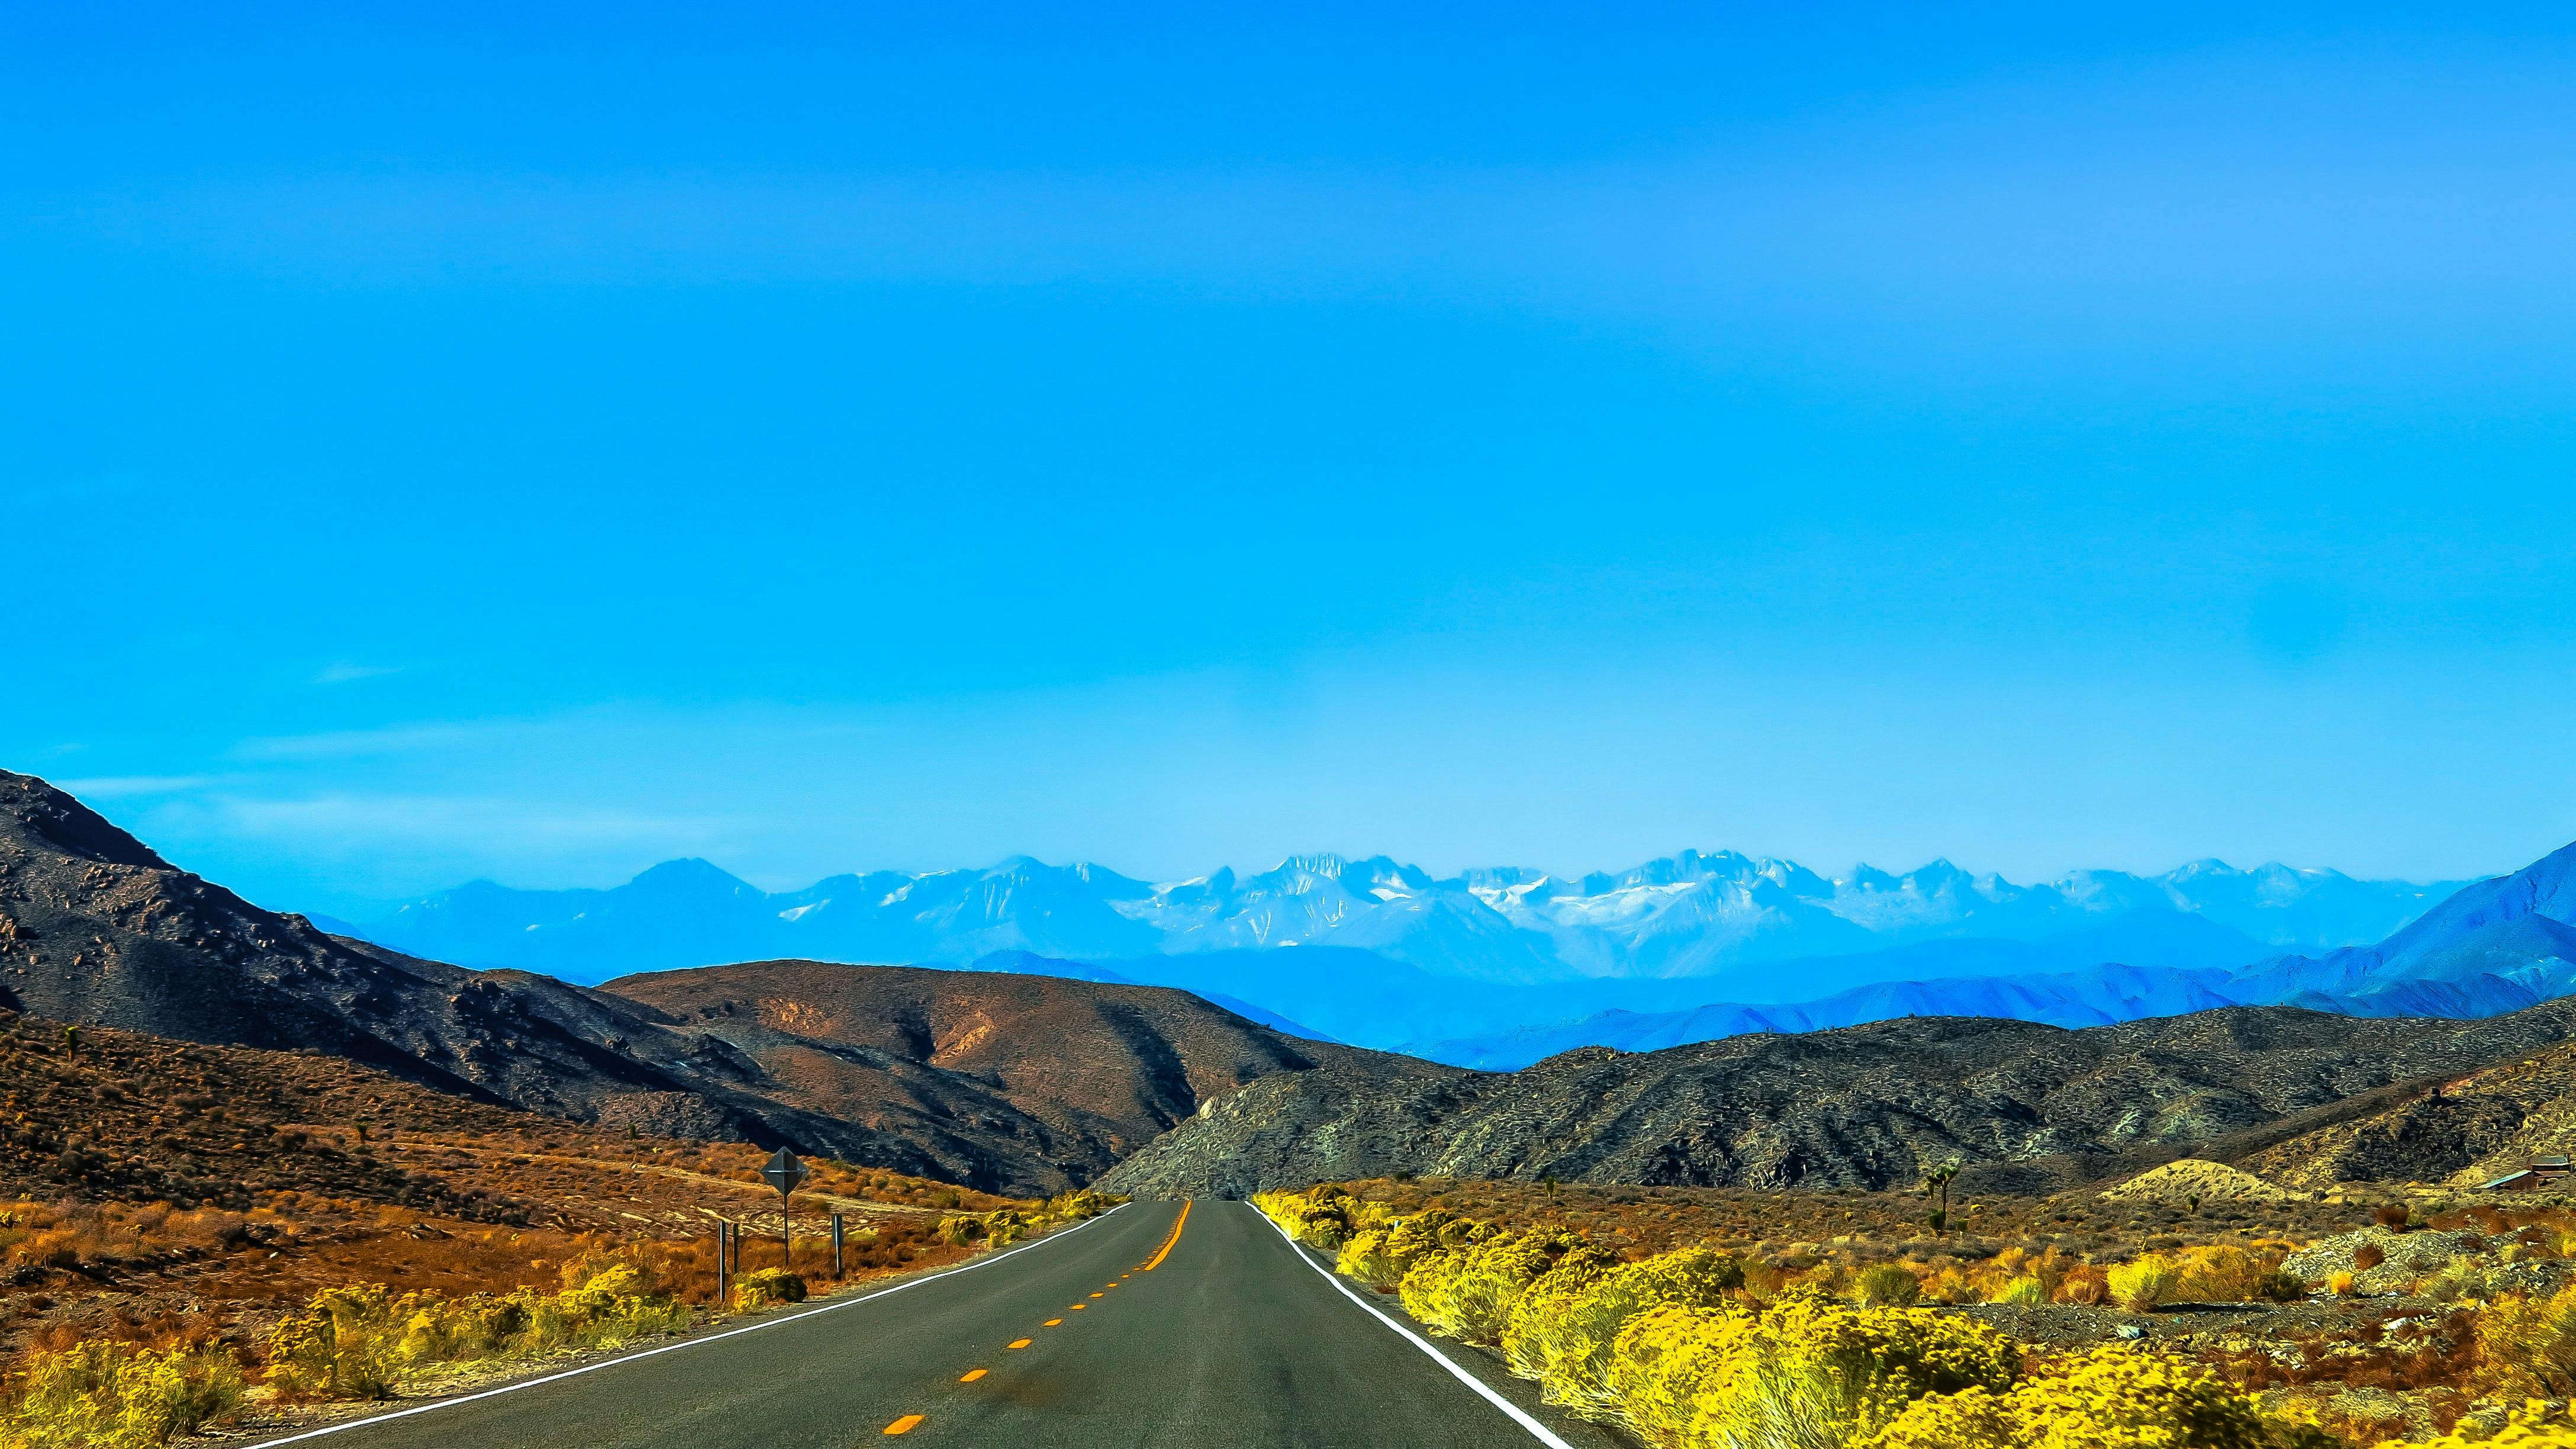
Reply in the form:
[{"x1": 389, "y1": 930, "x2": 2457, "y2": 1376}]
[{"x1": 268, "y1": 1258, "x2": 690, "y2": 1400}]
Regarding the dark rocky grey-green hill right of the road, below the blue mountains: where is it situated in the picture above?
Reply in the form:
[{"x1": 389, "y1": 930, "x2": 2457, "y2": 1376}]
[{"x1": 1103, "y1": 1003, "x2": 2576, "y2": 1194}]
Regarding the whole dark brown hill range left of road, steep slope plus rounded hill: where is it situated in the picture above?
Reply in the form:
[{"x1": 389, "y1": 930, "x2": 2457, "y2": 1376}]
[{"x1": 0, "y1": 771, "x2": 1401, "y2": 1191}]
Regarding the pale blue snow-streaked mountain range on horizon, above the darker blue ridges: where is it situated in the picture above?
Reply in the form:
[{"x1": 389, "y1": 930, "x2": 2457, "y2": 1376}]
[{"x1": 348, "y1": 851, "x2": 2455, "y2": 990}]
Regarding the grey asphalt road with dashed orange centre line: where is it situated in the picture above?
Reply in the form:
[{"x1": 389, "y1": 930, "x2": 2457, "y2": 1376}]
[{"x1": 246, "y1": 1202, "x2": 1608, "y2": 1449}]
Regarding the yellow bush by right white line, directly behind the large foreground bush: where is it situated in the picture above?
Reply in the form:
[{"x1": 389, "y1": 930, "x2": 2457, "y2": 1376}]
[{"x1": 1502, "y1": 1248, "x2": 1744, "y2": 1413}]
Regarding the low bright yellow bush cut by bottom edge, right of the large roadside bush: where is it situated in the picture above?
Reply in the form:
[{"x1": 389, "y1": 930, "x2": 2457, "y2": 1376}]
[{"x1": 1857, "y1": 1348, "x2": 2336, "y2": 1449}]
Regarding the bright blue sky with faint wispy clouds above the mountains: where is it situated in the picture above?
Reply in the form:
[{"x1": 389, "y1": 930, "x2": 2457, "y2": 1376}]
[{"x1": 0, "y1": 2, "x2": 2576, "y2": 913}]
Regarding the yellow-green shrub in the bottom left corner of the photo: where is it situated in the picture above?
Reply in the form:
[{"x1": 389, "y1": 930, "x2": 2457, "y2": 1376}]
[{"x1": 0, "y1": 1343, "x2": 242, "y2": 1449}]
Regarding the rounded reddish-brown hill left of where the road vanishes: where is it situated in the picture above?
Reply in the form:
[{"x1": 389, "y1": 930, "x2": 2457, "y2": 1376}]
[{"x1": 603, "y1": 962, "x2": 1437, "y2": 1186}]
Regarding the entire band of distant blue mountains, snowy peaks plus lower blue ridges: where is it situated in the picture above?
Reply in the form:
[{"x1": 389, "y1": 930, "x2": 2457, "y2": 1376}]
[{"x1": 335, "y1": 848, "x2": 2514, "y2": 1067}]
